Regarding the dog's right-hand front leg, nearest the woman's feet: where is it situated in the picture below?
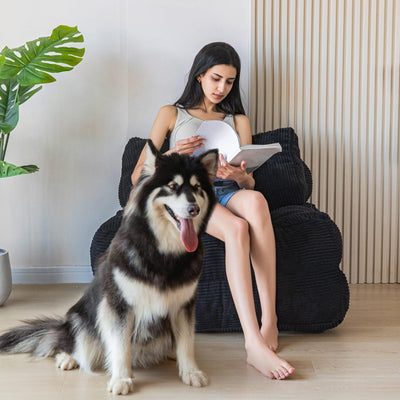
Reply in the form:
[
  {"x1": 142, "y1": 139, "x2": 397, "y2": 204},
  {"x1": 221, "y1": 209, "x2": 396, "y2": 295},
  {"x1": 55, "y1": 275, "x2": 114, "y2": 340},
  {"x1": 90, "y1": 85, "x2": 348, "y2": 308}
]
[{"x1": 172, "y1": 304, "x2": 208, "y2": 387}]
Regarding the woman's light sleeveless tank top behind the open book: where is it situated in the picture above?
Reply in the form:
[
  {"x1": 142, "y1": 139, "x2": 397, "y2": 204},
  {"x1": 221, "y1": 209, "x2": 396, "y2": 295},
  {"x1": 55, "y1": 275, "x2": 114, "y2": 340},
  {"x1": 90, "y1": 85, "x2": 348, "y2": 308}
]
[{"x1": 169, "y1": 107, "x2": 236, "y2": 149}]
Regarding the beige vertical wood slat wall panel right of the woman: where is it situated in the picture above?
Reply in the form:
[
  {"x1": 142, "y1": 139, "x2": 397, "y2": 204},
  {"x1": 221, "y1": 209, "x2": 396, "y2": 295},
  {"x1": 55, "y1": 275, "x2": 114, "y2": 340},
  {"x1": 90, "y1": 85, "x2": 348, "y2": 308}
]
[{"x1": 251, "y1": 0, "x2": 400, "y2": 283}]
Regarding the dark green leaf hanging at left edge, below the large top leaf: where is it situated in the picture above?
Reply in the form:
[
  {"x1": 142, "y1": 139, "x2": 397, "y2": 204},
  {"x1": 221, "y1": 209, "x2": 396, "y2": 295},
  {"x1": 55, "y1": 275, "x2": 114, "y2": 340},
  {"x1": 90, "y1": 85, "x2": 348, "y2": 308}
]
[{"x1": 0, "y1": 79, "x2": 19, "y2": 134}]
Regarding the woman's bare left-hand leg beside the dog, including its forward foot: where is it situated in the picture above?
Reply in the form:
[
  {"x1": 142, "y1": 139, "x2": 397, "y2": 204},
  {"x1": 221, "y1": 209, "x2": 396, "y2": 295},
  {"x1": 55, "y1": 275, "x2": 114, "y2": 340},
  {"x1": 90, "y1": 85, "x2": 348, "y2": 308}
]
[{"x1": 207, "y1": 203, "x2": 294, "y2": 379}]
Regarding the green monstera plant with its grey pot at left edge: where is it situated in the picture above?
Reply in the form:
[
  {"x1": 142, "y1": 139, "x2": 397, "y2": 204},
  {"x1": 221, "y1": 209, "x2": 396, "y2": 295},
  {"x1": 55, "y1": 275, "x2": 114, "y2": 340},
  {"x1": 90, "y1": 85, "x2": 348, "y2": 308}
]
[{"x1": 0, "y1": 25, "x2": 85, "y2": 305}]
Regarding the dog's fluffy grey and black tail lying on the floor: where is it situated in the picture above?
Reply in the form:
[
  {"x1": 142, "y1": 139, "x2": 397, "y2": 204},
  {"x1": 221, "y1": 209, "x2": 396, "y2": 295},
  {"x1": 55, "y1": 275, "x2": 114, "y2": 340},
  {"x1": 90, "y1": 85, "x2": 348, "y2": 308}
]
[{"x1": 0, "y1": 318, "x2": 66, "y2": 357}]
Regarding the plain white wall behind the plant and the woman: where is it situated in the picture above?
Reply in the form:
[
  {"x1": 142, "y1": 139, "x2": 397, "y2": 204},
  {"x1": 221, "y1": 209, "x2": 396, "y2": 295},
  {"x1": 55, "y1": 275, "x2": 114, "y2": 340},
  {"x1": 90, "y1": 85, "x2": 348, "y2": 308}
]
[{"x1": 0, "y1": 0, "x2": 250, "y2": 274}]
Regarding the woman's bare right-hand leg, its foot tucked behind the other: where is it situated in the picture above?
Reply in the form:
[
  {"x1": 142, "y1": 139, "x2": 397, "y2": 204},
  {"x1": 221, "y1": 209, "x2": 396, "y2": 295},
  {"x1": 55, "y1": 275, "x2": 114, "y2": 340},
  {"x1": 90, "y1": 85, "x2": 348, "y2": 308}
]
[{"x1": 227, "y1": 190, "x2": 278, "y2": 351}]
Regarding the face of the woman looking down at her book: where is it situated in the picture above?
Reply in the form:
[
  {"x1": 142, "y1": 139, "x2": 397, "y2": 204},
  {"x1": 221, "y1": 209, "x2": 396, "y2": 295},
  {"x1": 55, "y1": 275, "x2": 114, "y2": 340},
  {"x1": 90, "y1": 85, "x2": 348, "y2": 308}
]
[{"x1": 197, "y1": 64, "x2": 236, "y2": 104}]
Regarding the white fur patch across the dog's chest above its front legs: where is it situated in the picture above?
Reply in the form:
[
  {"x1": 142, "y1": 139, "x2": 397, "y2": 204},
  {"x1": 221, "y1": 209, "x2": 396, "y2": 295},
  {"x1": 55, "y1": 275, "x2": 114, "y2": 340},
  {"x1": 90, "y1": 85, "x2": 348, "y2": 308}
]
[{"x1": 114, "y1": 269, "x2": 197, "y2": 323}]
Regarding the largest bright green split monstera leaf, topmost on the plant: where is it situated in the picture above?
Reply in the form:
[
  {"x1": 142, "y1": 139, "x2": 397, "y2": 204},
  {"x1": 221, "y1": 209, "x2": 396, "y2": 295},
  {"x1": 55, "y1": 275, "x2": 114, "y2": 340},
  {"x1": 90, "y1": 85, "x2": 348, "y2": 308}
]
[{"x1": 0, "y1": 25, "x2": 85, "y2": 86}]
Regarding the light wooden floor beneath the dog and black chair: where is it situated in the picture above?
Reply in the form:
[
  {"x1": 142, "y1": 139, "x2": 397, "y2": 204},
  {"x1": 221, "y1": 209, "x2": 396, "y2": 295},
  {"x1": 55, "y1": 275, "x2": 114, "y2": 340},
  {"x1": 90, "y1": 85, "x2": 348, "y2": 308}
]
[{"x1": 0, "y1": 284, "x2": 400, "y2": 400}]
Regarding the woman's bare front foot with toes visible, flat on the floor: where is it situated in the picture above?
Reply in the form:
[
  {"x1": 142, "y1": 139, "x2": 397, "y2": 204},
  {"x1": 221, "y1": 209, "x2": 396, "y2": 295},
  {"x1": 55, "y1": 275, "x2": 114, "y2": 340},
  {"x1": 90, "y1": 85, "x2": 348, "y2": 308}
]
[{"x1": 246, "y1": 339, "x2": 295, "y2": 380}]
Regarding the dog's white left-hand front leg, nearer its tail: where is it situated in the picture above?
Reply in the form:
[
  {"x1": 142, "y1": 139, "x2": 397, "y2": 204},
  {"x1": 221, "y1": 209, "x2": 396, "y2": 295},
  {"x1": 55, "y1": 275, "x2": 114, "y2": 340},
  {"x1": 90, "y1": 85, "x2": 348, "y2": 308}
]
[{"x1": 98, "y1": 300, "x2": 133, "y2": 394}]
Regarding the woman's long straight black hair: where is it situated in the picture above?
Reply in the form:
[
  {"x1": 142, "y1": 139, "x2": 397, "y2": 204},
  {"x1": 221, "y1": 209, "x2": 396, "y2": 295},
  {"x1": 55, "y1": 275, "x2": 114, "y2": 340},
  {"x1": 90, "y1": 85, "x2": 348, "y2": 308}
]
[{"x1": 174, "y1": 42, "x2": 245, "y2": 115}]
